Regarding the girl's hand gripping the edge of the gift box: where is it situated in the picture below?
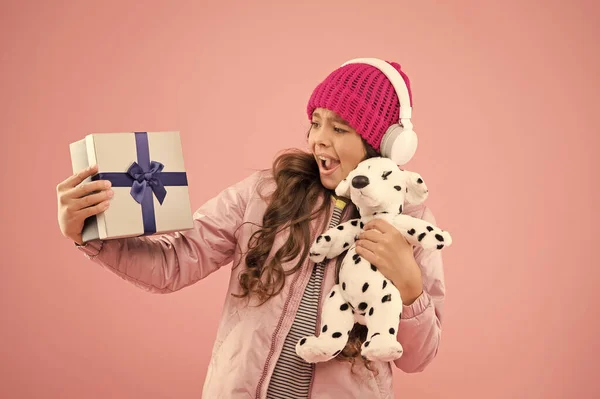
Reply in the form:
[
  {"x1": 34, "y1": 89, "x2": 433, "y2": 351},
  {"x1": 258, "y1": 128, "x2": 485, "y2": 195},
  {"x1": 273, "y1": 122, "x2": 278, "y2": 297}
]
[{"x1": 56, "y1": 165, "x2": 112, "y2": 245}]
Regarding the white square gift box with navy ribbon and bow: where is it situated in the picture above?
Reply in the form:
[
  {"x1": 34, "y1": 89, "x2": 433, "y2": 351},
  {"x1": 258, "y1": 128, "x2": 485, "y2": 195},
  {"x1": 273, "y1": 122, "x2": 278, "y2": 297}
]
[{"x1": 70, "y1": 132, "x2": 193, "y2": 242}]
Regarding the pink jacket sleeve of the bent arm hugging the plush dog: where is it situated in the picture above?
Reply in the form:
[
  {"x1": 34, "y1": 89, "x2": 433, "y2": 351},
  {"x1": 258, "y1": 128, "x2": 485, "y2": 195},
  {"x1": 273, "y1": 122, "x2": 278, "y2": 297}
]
[{"x1": 394, "y1": 207, "x2": 446, "y2": 373}]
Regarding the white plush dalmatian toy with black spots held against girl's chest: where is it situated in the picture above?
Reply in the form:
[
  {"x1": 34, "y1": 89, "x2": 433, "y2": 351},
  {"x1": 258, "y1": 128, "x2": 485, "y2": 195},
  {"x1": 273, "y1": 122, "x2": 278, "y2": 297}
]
[{"x1": 296, "y1": 157, "x2": 452, "y2": 363}]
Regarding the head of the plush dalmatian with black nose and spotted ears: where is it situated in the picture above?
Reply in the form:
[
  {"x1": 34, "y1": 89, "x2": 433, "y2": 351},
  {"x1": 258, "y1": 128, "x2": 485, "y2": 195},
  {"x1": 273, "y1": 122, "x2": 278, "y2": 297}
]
[{"x1": 335, "y1": 157, "x2": 429, "y2": 215}]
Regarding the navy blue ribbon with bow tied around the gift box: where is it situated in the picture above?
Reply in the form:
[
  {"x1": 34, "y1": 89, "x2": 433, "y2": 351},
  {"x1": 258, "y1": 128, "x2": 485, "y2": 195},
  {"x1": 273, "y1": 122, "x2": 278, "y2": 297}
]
[{"x1": 92, "y1": 132, "x2": 188, "y2": 235}]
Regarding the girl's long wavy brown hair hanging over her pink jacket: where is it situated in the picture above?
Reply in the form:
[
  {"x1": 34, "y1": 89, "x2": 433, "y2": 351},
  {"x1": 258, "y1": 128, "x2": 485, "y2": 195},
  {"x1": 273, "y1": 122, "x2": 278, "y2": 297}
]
[{"x1": 232, "y1": 134, "x2": 379, "y2": 372}]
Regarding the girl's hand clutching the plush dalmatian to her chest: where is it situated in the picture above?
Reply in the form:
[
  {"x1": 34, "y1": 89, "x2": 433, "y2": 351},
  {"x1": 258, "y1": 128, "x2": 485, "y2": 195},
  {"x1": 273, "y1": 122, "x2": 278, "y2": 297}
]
[{"x1": 356, "y1": 219, "x2": 423, "y2": 306}]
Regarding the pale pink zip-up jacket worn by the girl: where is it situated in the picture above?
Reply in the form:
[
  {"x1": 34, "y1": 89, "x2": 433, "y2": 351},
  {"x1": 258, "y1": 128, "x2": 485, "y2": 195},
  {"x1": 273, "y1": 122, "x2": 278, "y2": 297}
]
[{"x1": 78, "y1": 172, "x2": 445, "y2": 399}]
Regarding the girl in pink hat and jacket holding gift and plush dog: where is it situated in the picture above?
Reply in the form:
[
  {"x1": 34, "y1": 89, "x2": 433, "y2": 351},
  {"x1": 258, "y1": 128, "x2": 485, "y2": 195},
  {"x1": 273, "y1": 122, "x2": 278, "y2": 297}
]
[{"x1": 57, "y1": 58, "x2": 445, "y2": 399}]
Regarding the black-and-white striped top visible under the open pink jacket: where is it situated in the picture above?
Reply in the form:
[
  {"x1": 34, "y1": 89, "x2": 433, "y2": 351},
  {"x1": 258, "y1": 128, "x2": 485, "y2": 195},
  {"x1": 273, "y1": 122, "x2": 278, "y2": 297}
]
[{"x1": 267, "y1": 199, "x2": 346, "y2": 399}]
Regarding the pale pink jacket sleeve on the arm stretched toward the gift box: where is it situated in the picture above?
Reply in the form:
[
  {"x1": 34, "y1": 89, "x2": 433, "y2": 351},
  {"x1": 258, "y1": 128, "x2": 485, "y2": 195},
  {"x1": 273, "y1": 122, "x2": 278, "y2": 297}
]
[{"x1": 76, "y1": 172, "x2": 260, "y2": 294}]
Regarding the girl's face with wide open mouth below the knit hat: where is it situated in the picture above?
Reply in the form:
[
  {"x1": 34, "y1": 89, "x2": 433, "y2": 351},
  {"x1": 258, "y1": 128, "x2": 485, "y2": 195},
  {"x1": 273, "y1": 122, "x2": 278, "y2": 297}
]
[{"x1": 308, "y1": 108, "x2": 366, "y2": 190}]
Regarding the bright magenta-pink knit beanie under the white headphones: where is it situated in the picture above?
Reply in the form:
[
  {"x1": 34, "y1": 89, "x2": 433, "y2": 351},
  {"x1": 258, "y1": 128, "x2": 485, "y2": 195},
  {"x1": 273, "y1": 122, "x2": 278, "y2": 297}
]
[{"x1": 306, "y1": 61, "x2": 412, "y2": 152}]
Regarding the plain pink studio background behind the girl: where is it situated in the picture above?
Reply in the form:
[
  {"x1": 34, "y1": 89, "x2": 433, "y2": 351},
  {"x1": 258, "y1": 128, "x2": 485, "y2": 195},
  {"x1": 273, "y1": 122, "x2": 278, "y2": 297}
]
[{"x1": 0, "y1": 0, "x2": 600, "y2": 399}]
